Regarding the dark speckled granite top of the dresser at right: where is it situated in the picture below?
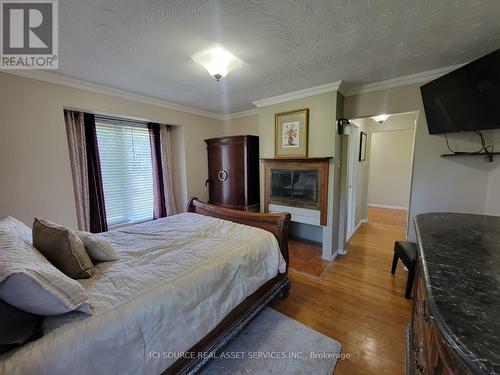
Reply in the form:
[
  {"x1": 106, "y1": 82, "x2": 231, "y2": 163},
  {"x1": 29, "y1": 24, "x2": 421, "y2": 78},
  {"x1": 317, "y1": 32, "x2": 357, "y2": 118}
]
[{"x1": 415, "y1": 213, "x2": 500, "y2": 374}]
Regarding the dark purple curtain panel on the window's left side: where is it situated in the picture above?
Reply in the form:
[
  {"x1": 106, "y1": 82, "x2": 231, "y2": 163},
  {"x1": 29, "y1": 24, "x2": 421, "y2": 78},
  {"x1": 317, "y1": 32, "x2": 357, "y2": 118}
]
[{"x1": 84, "y1": 113, "x2": 108, "y2": 233}]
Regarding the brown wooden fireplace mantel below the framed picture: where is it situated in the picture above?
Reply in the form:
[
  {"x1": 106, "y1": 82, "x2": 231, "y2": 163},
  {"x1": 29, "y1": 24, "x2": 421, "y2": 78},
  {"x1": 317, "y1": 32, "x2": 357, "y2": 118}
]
[{"x1": 261, "y1": 157, "x2": 332, "y2": 226}]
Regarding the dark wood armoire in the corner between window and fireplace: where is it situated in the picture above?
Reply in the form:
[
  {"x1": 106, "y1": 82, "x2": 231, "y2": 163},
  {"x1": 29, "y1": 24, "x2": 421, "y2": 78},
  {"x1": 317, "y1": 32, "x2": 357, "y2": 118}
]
[{"x1": 205, "y1": 135, "x2": 260, "y2": 211}]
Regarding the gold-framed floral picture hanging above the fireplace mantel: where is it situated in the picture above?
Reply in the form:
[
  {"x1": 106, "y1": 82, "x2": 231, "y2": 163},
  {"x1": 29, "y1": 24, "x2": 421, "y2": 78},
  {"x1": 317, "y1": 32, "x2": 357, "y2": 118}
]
[{"x1": 274, "y1": 108, "x2": 309, "y2": 158}]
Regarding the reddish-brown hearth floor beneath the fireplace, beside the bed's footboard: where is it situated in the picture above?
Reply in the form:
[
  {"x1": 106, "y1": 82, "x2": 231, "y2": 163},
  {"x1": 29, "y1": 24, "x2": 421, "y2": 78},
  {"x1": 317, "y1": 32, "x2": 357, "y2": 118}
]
[{"x1": 288, "y1": 238, "x2": 333, "y2": 280}]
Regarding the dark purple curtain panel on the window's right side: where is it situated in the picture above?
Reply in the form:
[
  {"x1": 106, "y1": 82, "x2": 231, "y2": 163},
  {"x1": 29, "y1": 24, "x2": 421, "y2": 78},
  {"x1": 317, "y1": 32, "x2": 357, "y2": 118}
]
[{"x1": 148, "y1": 123, "x2": 167, "y2": 219}]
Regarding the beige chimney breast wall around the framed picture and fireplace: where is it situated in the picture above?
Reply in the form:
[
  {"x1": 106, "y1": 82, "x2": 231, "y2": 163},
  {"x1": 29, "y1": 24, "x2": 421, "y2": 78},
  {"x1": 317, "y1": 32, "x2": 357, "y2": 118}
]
[{"x1": 258, "y1": 92, "x2": 340, "y2": 258}]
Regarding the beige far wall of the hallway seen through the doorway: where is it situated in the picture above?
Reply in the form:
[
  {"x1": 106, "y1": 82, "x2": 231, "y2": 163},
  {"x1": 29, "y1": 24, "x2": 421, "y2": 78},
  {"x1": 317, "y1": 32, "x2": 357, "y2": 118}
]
[{"x1": 368, "y1": 129, "x2": 413, "y2": 208}]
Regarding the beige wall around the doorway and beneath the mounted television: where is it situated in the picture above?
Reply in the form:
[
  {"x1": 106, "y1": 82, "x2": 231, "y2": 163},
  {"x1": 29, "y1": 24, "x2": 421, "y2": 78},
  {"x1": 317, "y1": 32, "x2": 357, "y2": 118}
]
[{"x1": 344, "y1": 84, "x2": 500, "y2": 240}]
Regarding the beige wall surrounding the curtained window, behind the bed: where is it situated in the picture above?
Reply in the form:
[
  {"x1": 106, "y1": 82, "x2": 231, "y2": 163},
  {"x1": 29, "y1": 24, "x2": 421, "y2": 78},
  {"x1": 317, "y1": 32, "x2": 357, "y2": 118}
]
[{"x1": 0, "y1": 73, "x2": 224, "y2": 227}]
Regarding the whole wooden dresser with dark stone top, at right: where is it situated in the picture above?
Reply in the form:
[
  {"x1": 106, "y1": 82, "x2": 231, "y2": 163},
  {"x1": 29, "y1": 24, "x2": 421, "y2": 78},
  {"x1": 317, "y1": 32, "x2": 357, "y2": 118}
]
[{"x1": 407, "y1": 213, "x2": 500, "y2": 375}]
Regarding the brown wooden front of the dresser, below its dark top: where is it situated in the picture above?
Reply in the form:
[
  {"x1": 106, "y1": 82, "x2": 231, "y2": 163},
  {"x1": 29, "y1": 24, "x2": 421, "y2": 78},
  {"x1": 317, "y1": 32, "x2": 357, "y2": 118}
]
[{"x1": 407, "y1": 264, "x2": 472, "y2": 375}]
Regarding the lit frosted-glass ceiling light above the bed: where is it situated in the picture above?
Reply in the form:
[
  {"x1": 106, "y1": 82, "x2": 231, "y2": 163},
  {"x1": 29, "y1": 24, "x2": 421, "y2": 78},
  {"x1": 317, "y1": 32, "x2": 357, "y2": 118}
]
[{"x1": 193, "y1": 46, "x2": 243, "y2": 81}]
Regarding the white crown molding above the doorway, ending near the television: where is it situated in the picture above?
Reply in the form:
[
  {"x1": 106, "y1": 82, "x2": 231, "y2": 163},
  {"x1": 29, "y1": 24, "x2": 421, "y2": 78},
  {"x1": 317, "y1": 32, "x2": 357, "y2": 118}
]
[{"x1": 345, "y1": 64, "x2": 465, "y2": 96}]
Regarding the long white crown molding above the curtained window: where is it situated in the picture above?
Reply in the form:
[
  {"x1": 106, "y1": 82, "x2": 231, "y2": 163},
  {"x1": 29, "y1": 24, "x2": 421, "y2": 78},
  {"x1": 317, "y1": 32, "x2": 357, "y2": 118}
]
[{"x1": 1, "y1": 70, "x2": 227, "y2": 120}]
